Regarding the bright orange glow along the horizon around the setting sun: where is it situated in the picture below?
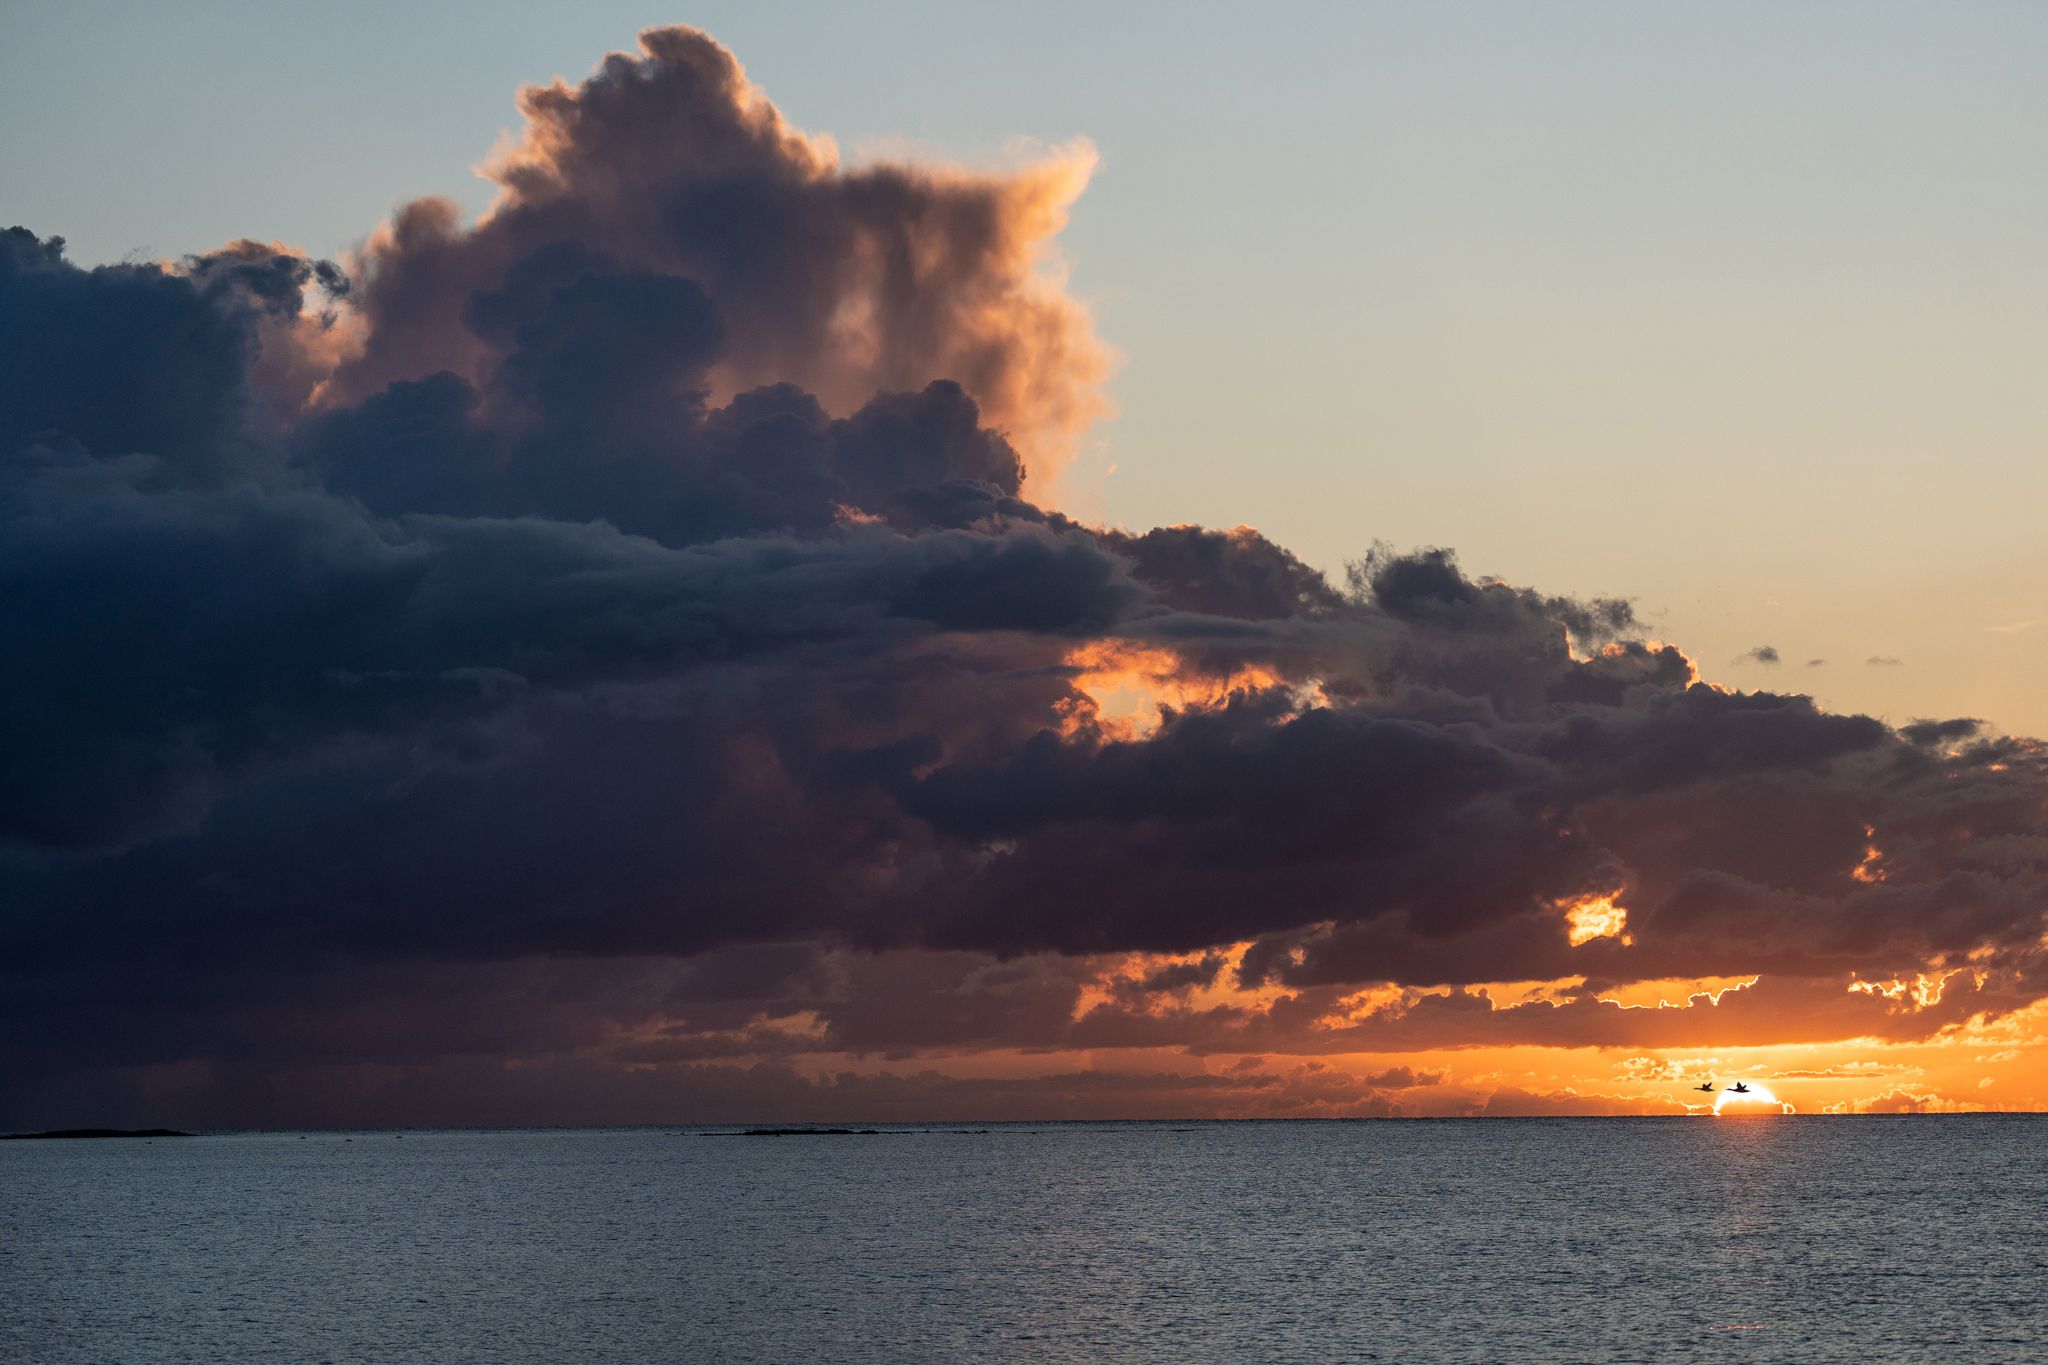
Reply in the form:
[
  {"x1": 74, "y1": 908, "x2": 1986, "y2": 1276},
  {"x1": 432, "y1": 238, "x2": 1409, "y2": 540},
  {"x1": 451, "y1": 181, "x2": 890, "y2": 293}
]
[{"x1": 1048, "y1": 957, "x2": 2048, "y2": 1117}]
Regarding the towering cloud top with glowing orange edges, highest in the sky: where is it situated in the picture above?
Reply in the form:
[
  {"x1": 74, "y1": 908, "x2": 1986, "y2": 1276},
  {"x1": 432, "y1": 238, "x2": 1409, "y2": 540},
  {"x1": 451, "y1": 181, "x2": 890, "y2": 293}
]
[{"x1": 326, "y1": 27, "x2": 1108, "y2": 489}]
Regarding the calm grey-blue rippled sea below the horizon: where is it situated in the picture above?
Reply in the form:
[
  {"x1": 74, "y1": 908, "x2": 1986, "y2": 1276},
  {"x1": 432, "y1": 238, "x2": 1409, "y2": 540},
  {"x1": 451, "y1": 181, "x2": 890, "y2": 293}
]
[{"x1": 0, "y1": 1117, "x2": 2048, "y2": 1361}]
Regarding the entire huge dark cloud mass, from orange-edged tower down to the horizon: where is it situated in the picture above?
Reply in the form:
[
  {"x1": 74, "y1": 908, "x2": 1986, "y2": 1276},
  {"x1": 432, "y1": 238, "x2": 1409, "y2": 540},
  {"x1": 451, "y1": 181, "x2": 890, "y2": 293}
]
[{"x1": 0, "y1": 29, "x2": 2048, "y2": 1126}]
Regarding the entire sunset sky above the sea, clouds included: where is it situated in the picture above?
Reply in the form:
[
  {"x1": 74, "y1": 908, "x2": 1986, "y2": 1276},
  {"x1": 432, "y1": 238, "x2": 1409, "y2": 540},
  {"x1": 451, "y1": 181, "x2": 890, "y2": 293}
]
[{"x1": 0, "y1": 4, "x2": 2048, "y2": 1126}]
